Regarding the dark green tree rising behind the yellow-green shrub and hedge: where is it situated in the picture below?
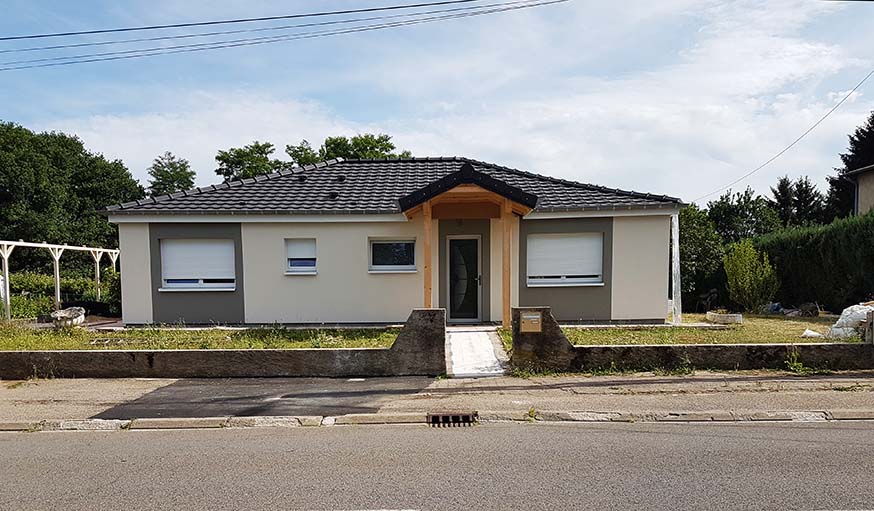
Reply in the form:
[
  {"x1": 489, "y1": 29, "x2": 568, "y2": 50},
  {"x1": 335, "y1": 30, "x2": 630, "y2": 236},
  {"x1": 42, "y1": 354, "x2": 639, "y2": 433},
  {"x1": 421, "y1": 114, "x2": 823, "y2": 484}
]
[{"x1": 707, "y1": 187, "x2": 780, "y2": 243}]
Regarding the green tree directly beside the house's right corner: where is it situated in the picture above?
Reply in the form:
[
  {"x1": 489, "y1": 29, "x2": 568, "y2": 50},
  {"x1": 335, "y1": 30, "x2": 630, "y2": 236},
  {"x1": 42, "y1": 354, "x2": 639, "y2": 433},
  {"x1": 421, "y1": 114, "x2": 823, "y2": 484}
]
[{"x1": 680, "y1": 204, "x2": 724, "y2": 293}]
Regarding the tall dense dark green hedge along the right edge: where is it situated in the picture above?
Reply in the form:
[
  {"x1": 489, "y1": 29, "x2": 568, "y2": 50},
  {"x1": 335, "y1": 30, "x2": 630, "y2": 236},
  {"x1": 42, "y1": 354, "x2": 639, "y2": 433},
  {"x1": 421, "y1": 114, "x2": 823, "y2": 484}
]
[{"x1": 755, "y1": 211, "x2": 874, "y2": 312}]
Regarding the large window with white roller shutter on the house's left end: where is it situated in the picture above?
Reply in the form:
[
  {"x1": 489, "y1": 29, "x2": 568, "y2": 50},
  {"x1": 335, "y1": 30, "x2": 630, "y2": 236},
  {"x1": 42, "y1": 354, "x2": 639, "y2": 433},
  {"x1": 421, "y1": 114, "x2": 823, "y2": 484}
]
[{"x1": 160, "y1": 239, "x2": 236, "y2": 291}]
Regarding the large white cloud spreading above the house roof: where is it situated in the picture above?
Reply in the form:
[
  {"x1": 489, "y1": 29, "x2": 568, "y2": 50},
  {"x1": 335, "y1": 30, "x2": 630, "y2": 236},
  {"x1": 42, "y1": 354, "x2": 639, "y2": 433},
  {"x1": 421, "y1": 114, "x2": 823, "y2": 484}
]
[{"x1": 40, "y1": 1, "x2": 874, "y2": 206}]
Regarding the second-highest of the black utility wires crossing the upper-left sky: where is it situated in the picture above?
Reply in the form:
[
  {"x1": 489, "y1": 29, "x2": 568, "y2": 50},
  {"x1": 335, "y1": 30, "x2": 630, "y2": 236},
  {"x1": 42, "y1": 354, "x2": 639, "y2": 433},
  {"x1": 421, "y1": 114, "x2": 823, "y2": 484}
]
[{"x1": 0, "y1": 0, "x2": 535, "y2": 54}]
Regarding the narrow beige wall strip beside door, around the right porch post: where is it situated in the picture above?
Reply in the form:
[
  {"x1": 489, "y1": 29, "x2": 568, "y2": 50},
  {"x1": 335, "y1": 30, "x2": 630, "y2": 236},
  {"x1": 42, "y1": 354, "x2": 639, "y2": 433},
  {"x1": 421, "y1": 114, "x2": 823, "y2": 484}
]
[{"x1": 488, "y1": 216, "x2": 519, "y2": 322}]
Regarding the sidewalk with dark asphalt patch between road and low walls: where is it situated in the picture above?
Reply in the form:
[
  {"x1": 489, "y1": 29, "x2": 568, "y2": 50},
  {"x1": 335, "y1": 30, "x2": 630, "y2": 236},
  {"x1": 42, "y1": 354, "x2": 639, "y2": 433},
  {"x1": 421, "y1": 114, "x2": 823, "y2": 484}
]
[{"x1": 0, "y1": 372, "x2": 874, "y2": 429}]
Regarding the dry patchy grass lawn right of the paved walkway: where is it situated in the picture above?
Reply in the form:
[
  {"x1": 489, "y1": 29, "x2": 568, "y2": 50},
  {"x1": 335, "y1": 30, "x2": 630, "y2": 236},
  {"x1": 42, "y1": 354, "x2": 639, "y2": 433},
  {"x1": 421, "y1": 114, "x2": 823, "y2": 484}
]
[{"x1": 498, "y1": 314, "x2": 861, "y2": 351}]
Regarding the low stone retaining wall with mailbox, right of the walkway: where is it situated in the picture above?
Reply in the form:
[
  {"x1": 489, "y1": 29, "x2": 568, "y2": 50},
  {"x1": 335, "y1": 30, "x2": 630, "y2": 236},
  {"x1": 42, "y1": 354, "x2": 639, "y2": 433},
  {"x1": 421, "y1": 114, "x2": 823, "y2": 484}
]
[{"x1": 511, "y1": 307, "x2": 874, "y2": 372}]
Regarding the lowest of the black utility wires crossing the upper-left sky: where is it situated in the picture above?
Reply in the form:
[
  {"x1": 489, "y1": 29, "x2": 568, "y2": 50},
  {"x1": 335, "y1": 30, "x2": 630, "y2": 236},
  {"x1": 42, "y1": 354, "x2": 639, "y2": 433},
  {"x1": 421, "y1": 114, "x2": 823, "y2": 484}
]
[{"x1": 0, "y1": 0, "x2": 570, "y2": 72}]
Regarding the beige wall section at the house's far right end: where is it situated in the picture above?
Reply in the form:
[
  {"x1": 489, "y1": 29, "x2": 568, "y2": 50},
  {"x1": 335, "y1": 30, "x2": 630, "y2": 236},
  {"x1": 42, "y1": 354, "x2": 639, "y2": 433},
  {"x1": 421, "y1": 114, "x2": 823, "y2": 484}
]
[{"x1": 611, "y1": 215, "x2": 671, "y2": 320}]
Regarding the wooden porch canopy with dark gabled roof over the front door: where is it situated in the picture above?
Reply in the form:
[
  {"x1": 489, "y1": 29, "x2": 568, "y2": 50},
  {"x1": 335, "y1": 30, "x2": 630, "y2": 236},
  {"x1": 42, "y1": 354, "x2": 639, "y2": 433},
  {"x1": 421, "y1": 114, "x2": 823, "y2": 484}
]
[{"x1": 398, "y1": 163, "x2": 537, "y2": 327}]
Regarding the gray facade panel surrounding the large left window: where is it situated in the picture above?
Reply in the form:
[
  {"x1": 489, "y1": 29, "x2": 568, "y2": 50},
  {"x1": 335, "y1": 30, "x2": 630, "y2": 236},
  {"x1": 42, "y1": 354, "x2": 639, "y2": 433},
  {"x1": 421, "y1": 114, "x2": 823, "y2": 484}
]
[{"x1": 149, "y1": 223, "x2": 246, "y2": 324}]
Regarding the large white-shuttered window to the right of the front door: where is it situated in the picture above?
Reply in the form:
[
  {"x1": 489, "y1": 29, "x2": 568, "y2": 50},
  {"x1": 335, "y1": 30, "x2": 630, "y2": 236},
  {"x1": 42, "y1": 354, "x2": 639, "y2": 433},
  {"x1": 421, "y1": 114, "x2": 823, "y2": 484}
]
[{"x1": 528, "y1": 233, "x2": 604, "y2": 287}]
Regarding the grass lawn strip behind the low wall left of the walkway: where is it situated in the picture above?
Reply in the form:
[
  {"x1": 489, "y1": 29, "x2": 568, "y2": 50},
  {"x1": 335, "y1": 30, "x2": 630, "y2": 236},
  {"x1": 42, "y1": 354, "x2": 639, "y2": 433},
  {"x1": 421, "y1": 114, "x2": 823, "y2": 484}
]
[{"x1": 0, "y1": 325, "x2": 400, "y2": 351}]
